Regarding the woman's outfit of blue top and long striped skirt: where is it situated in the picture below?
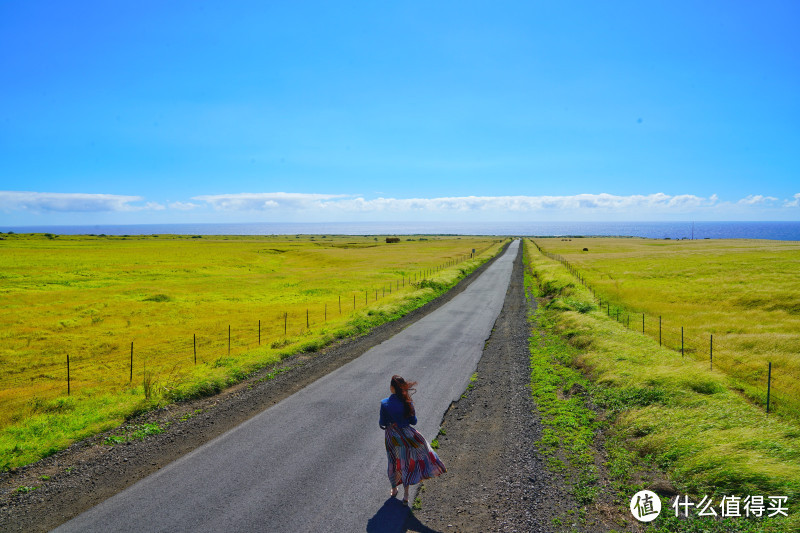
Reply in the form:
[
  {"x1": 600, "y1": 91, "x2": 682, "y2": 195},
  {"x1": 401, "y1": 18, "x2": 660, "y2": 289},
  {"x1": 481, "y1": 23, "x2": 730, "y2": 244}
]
[{"x1": 380, "y1": 395, "x2": 447, "y2": 487}]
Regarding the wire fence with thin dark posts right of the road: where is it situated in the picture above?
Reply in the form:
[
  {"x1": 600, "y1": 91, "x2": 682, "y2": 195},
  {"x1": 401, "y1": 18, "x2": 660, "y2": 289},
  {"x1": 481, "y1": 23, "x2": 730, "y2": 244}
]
[{"x1": 531, "y1": 241, "x2": 800, "y2": 419}]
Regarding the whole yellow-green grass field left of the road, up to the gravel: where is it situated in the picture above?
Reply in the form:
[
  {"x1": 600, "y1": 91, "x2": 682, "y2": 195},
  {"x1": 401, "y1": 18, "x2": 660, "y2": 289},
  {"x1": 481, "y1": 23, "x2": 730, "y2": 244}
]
[{"x1": 0, "y1": 235, "x2": 501, "y2": 468}]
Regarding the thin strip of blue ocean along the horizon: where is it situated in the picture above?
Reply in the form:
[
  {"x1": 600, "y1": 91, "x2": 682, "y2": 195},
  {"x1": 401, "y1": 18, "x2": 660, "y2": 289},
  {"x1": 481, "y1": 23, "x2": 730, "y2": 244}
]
[{"x1": 0, "y1": 222, "x2": 800, "y2": 241}]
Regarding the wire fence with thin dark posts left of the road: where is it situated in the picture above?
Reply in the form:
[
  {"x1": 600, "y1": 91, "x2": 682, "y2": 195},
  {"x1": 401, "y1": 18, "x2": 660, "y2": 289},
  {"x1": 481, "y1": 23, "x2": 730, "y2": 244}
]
[{"x1": 0, "y1": 241, "x2": 498, "y2": 425}]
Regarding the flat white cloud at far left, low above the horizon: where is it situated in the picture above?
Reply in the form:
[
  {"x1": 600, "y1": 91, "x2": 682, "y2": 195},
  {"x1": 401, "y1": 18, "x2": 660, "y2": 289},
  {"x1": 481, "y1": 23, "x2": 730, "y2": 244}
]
[{"x1": 0, "y1": 191, "x2": 159, "y2": 213}]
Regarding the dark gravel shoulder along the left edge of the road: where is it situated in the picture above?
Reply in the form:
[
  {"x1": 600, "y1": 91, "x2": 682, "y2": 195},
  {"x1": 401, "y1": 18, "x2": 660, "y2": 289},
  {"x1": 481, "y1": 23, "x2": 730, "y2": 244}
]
[{"x1": 0, "y1": 243, "x2": 508, "y2": 532}]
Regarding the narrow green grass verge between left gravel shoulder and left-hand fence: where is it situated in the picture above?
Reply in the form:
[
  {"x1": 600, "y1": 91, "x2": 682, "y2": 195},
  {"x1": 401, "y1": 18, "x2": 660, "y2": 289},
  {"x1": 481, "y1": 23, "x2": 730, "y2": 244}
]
[{"x1": 0, "y1": 235, "x2": 510, "y2": 470}]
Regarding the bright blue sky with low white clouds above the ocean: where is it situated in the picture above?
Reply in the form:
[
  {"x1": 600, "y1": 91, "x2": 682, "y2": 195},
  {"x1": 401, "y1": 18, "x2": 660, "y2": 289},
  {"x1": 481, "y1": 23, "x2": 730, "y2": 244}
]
[{"x1": 0, "y1": 0, "x2": 800, "y2": 226}]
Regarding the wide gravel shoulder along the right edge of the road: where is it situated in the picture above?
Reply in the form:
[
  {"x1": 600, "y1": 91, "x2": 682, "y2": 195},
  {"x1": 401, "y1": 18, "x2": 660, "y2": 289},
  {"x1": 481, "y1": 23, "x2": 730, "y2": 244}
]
[{"x1": 406, "y1": 242, "x2": 570, "y2": 533}]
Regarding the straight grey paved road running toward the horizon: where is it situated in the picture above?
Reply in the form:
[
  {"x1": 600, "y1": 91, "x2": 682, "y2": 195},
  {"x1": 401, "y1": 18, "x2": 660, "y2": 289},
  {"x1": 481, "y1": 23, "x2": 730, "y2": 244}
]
[{"x1": 55, "y1": 241, "x2": 519, "y2": 533}]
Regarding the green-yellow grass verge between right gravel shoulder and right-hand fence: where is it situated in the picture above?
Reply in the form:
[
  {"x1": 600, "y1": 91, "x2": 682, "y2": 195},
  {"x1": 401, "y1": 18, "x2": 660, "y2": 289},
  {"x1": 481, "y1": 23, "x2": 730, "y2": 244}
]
[{"x1": 525, "y1": 242, "x2": 800, "y2": 532}]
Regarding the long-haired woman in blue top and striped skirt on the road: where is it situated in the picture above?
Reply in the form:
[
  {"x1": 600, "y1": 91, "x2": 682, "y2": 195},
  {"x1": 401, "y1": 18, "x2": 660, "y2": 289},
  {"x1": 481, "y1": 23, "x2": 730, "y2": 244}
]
[{"x1": 379, "y1": 376, "x2": 447, "y2": 505}]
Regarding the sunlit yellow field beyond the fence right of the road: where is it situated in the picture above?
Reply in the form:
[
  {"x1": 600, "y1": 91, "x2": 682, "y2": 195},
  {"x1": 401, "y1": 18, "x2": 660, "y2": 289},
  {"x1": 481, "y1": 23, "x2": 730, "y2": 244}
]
[{"x1": 535, "y1": 238, "x2": 800, "y2": 417}]
